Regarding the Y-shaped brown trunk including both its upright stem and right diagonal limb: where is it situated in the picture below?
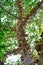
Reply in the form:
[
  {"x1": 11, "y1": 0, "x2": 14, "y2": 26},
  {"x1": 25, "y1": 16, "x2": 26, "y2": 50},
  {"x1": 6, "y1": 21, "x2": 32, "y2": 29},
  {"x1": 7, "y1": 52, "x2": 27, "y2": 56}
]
[{"x1": 16, "y1": 0, "x2": 42, "y2": 65}]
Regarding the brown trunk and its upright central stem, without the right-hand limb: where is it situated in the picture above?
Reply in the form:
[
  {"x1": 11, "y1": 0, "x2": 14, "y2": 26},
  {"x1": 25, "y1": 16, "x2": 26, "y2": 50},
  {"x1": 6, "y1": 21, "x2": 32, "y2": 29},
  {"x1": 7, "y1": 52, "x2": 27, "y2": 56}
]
[{"x1": 16, "y1": 0, "x2": 29, "y2": 60}]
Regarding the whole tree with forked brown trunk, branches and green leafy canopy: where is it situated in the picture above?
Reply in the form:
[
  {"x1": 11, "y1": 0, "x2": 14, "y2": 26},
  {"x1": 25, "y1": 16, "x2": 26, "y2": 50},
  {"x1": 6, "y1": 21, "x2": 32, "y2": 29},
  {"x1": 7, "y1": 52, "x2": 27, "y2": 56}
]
[{"x1": 0, "y1": 0, "x2": 43, "y2": 65}]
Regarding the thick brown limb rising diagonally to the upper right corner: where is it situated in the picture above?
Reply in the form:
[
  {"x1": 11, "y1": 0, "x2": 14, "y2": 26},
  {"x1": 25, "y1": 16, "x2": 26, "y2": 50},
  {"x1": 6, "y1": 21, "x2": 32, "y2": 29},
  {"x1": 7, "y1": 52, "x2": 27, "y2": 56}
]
[{"x1": 23, "y1": 1, "x2": 43, "y2": 26}]
